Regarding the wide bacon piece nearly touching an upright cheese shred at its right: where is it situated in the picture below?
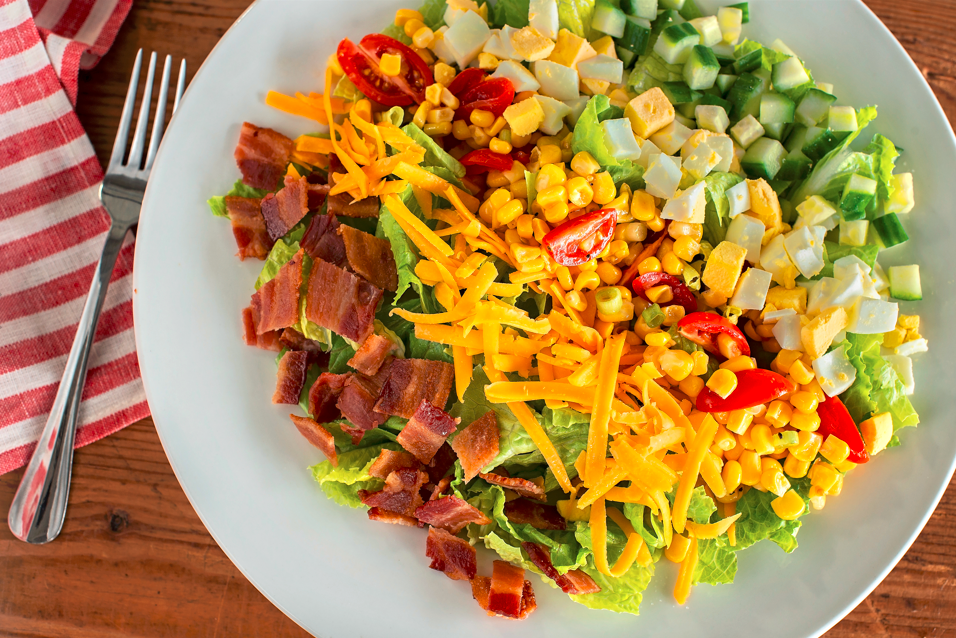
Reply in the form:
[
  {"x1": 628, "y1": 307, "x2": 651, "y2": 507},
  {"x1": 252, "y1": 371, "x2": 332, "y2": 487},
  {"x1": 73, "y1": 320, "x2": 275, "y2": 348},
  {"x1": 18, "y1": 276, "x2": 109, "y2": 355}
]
[{"x1": 374, "y1": 360, "x2": 455, "y2": 419}]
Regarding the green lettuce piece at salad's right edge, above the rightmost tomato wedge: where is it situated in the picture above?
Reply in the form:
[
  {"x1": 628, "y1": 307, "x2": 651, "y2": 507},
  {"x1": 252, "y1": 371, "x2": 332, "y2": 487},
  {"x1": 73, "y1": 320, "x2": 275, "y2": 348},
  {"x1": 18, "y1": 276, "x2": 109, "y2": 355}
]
[{"x1": 840, "y1": 333, "x2": 919, "y2": 432}]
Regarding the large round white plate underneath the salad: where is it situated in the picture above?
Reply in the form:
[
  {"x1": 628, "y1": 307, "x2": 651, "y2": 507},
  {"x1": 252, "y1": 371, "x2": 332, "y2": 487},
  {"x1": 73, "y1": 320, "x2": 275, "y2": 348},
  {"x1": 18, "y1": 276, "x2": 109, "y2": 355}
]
[{"x1": 134, "y1": 0, "x2": 956, "y2": 638}]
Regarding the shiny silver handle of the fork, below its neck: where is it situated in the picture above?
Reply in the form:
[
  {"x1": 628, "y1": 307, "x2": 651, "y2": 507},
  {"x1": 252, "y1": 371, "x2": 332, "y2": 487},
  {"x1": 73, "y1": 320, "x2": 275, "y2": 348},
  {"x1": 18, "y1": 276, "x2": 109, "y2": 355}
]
[{"x1": 7, "y1": 222, "x2": 130, "y2": 544}]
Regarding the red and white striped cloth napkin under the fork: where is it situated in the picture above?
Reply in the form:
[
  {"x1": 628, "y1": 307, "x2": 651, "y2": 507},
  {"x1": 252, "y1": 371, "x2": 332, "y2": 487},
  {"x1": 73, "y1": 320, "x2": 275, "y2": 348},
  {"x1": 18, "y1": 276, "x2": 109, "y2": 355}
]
[{"x1": 0, "y1": 0, "x2": 149, "y2": 474}]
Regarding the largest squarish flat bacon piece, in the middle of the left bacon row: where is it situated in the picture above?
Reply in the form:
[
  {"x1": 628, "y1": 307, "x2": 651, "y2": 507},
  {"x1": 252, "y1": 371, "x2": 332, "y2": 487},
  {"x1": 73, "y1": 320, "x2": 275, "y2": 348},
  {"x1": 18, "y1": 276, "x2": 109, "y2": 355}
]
[{"x1": 306, "y1": 259, "x2": 380, "y2": 348}]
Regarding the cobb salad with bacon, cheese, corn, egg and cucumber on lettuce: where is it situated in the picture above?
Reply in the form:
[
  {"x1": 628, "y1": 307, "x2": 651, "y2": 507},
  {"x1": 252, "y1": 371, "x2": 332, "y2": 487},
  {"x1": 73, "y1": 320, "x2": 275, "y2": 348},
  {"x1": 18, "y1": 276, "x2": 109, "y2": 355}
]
[{"x1": 209, "y1": 0, "x2": 927, "y2": 619}]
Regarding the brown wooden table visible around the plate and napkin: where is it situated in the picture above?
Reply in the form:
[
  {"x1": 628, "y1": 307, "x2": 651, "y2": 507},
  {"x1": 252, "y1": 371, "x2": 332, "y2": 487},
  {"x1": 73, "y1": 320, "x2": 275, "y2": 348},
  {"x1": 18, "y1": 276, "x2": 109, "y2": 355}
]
[{"x1": 0, "y1": 0, "x2": 956, "y2": 638}]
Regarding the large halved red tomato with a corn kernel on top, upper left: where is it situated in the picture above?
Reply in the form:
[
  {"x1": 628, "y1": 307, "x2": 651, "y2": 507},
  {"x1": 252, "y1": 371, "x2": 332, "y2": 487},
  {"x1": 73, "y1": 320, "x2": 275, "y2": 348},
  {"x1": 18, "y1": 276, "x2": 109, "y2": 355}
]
[{"x1": 336, "y1": 33, "x2": 435, "y2": 106}]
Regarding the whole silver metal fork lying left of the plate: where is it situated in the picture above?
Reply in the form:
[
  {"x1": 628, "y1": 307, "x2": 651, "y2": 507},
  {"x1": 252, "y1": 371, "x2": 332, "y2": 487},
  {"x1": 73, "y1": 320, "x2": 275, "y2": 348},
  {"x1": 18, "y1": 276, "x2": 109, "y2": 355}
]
[{"x1": 7, "y1": 49, "x2": 186, "y2": 544}]
